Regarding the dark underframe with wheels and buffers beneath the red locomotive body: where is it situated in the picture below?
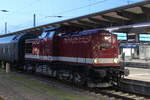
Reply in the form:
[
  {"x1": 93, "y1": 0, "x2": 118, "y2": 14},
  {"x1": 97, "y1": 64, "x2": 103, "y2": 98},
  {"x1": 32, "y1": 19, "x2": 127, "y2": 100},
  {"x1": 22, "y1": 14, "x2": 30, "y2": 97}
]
[{"x1": 23, "y1": 60, "x2": 128, "y2": 87}]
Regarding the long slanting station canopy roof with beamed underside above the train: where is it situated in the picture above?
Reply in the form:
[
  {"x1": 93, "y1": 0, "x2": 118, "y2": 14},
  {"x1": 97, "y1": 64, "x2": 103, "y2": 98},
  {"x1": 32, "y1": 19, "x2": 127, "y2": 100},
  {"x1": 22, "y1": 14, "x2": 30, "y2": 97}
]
[{"x1": 2, "y1": 0, "x2": 150, "y2": 36}]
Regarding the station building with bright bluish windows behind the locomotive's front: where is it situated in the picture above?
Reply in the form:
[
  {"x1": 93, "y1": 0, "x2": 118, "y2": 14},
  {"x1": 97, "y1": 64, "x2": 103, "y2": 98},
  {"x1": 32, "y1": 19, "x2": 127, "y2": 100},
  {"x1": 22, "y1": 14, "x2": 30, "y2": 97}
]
[{"x1": 113, "y1": 32, "x2": 150, "y2": 60}]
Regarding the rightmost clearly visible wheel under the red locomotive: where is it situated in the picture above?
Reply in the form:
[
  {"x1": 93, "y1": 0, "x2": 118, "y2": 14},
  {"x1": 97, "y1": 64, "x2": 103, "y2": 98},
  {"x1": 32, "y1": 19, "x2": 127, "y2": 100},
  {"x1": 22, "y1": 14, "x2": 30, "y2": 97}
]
[{"x1": 73, "y1": 72, "x2": 85, "y2": 86}]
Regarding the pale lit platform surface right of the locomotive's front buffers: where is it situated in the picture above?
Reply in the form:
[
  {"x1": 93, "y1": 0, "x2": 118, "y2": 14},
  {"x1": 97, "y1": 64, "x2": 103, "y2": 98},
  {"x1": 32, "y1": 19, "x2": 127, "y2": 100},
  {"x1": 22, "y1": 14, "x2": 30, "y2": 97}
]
[{"x1": 125, "y1": 67, "x2": 150, "y2": 82}]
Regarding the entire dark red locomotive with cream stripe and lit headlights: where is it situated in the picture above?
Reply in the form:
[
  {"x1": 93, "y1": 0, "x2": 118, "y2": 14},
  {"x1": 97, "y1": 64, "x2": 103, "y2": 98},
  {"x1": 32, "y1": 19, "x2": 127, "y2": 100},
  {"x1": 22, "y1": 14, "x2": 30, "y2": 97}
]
[{"x1": 24, "y1": 28, "x2": 128, "y2": 87}]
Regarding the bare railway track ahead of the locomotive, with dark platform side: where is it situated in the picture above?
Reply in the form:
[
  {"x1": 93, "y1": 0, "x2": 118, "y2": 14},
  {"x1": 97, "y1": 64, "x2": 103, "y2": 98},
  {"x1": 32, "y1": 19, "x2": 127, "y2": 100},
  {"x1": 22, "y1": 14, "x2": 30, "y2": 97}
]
[{"x1": 92, "y1": 79, "x2": 150, "y2": 100}]
